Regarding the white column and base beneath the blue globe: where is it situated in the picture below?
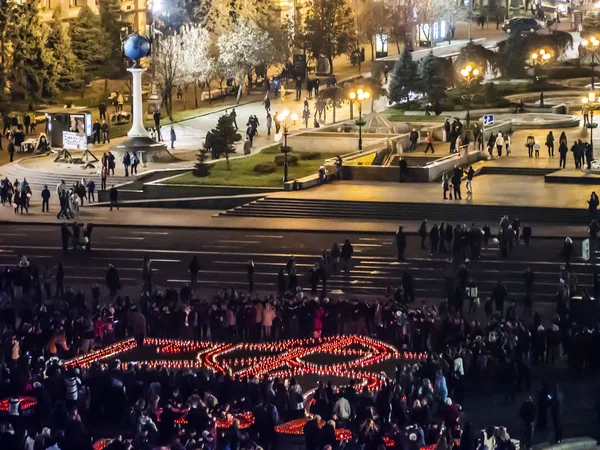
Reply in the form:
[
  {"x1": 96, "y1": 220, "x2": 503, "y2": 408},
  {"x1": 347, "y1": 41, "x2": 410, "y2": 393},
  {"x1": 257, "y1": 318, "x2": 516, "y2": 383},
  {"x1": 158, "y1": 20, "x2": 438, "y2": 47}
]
[{"x1": 110, "y1": 66, "x2": 175, "y2": 164}]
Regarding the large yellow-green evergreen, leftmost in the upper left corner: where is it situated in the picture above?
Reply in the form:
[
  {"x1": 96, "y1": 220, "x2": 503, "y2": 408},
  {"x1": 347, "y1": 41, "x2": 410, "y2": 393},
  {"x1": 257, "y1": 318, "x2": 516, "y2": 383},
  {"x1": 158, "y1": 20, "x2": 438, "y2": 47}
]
[{"x1": 9, "y1": 1, "x2": 58, "y2": 103}]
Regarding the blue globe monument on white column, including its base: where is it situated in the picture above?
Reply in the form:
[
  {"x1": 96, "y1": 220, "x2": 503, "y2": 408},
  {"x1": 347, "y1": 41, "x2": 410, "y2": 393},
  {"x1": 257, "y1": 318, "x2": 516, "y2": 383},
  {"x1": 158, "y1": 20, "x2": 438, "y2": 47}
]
[{"x1": 111, "y1": 33, "x2": 174, "y2": 162}]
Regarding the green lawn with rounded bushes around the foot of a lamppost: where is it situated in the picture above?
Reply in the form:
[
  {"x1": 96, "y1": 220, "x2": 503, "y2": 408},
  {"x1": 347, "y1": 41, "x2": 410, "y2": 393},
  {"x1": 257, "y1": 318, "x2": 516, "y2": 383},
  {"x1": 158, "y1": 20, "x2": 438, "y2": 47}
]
[{"x1": 165, "y1": 145, "x2": 329, "y2": 188}]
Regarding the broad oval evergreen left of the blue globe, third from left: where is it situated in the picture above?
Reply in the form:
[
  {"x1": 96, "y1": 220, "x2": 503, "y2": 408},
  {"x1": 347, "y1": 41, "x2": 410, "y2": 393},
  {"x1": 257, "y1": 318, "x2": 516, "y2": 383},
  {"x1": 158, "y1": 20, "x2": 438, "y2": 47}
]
[{"x1": 69, "y1": 6, "x2": 111, "y2": 83}]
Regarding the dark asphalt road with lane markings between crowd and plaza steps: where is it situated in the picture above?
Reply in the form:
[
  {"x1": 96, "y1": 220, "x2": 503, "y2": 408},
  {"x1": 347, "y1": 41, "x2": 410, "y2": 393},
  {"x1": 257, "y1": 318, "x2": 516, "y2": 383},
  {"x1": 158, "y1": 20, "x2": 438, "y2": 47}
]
[{"x1": 0, "y1": 225, "x2": 591, "y2": 302}]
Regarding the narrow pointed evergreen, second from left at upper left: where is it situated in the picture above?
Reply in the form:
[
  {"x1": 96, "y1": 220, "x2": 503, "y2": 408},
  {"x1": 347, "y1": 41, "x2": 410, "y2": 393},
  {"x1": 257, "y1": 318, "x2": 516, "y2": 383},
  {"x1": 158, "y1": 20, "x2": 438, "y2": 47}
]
[{"x1": 46, "y1": 8, "x2": 81, "y2": 89}]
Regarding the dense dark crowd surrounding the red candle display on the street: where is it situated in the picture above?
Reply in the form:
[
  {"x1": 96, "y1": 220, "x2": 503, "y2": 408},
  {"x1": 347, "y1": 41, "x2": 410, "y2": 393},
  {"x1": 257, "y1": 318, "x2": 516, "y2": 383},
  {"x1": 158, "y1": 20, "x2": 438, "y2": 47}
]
[{"x1": 0, "y1": 217, "x2": 600, "y2": 450}]
